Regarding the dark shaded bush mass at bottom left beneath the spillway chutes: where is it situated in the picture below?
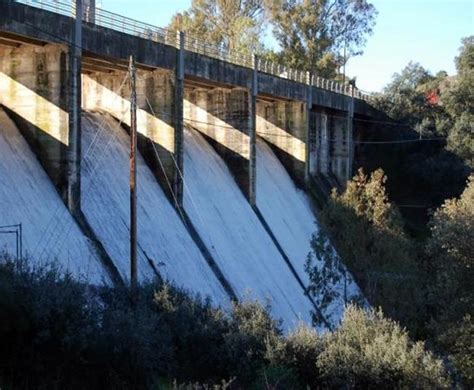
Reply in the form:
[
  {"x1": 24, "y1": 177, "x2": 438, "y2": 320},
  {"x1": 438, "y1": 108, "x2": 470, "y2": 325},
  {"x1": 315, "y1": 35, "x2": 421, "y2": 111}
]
[{"x1": 0, "y1": 258, "x2": 281, "y2": 389}]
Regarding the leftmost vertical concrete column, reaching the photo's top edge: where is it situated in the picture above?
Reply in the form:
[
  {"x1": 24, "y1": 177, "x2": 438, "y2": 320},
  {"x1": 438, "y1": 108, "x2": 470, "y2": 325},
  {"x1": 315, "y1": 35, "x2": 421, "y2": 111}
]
[{"x1": 66, "y1": 0, "x2": 82, "y2": 214}]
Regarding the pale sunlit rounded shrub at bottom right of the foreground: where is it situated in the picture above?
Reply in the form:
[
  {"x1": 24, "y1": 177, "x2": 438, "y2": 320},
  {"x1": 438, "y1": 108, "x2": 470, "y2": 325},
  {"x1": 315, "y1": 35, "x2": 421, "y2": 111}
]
[{"x1": 316, "y1": 306, "x2": 449, "y2": 388}]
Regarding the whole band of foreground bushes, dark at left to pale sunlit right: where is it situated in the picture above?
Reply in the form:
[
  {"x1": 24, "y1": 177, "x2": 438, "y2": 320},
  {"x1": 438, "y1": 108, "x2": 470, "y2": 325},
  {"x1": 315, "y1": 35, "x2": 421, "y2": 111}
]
[{"x1": 0, "y1": 259, "x2": 447, "y2": 389}]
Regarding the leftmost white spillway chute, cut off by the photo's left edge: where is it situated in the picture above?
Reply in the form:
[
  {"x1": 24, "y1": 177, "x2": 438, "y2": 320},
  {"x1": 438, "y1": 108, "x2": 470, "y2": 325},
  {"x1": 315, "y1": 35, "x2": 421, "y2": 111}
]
[{"x1": 0, "y1": 109, "x2": 103, "y2": 283}]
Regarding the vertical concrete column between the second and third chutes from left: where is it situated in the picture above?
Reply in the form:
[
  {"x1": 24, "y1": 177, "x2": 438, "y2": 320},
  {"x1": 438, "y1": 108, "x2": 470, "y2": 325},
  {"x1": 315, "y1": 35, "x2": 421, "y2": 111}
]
[{"x1": 173, "y1": 31, "x2": 185, "y2": 208}]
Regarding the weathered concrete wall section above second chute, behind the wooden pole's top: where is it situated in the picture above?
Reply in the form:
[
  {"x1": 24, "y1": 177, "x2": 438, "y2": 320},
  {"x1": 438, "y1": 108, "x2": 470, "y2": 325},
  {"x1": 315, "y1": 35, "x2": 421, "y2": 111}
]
[{"x1": 82, "y1": 70, "x2": 183, "y2": 205}]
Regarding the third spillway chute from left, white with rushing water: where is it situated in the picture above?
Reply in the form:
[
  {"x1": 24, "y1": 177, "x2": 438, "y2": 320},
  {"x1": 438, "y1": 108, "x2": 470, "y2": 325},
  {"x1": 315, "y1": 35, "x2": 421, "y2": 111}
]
[{"x1": 184, "y1": 129, "x2": 312, "y2": 327}]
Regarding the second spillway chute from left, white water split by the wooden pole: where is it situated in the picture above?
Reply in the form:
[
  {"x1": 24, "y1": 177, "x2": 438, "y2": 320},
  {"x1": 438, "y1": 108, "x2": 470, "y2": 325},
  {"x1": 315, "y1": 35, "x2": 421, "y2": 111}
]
[{"x1": 82, "y1": 113, "x2": 228, "y2": 305}]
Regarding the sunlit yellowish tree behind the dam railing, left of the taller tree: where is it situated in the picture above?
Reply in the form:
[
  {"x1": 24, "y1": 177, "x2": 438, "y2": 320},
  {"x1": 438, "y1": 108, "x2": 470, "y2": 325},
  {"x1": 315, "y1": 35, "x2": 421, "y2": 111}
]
[{"x1": 168, "y1": 0, "x2": 264, "y2": 55}]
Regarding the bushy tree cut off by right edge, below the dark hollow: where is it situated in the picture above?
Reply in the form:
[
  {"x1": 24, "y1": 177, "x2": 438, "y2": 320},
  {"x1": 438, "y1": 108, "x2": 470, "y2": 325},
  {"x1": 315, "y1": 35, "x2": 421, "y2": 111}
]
[{"x1": 426, "y1": 176, "x2": 474, "y2": 386}]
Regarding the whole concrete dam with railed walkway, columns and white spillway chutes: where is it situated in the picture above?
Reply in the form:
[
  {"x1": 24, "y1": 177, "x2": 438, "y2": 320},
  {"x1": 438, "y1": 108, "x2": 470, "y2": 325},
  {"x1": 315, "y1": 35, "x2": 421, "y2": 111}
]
[{"x1": 0, "y1": 0, "x2": 377, "y2": 329}]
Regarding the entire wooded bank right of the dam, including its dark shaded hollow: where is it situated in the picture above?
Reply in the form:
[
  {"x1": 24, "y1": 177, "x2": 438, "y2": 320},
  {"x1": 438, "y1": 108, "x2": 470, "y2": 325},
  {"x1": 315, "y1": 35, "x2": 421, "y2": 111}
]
[{"x1": 307, "y1": 37, "x2": 474, "y2": 388}]
